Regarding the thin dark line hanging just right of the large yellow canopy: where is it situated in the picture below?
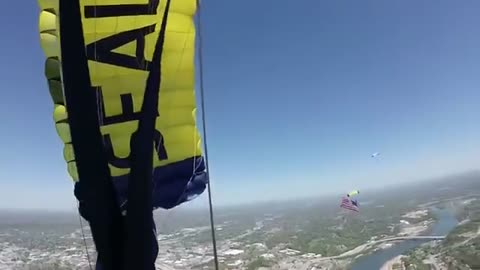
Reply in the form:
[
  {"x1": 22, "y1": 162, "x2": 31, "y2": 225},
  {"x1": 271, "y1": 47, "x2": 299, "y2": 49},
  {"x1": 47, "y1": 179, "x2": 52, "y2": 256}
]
[{"x1": 197, "y1": 0, "x2": 219, "y2": 270}]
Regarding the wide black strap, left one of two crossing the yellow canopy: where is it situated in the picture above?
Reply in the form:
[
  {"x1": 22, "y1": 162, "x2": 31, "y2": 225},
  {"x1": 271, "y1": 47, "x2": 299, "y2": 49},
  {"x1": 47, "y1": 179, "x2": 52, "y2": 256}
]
[{"x1": 58, "y1": 0, "x2": 123, "y2": 270}]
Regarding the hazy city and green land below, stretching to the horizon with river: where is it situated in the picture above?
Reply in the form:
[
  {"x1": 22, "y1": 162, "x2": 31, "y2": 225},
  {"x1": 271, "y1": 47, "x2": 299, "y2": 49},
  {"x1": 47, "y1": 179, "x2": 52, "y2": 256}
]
[{"x1": 0, "y1": 174, "x2": 480, "y2": 270}]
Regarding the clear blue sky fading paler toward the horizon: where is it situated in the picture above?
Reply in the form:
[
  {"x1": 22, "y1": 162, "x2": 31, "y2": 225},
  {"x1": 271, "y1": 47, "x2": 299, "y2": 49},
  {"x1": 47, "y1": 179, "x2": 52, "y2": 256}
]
[{"x1": 0, "y1": 0, "x2": 480, "y2": 208}]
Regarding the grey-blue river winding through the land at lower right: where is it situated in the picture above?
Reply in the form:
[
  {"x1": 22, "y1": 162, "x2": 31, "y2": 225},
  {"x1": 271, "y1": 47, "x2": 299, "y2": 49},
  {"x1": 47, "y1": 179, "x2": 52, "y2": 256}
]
[{"x1": 351, "y1": 208, "x2": 458, "y2": 270}]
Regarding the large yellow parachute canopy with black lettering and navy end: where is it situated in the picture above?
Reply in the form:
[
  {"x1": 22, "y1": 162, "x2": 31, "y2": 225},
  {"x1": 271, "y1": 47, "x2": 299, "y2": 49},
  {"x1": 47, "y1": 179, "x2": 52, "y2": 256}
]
[{"x1": 39, "y1": 0, "x2": 208, "y2": 209}]
